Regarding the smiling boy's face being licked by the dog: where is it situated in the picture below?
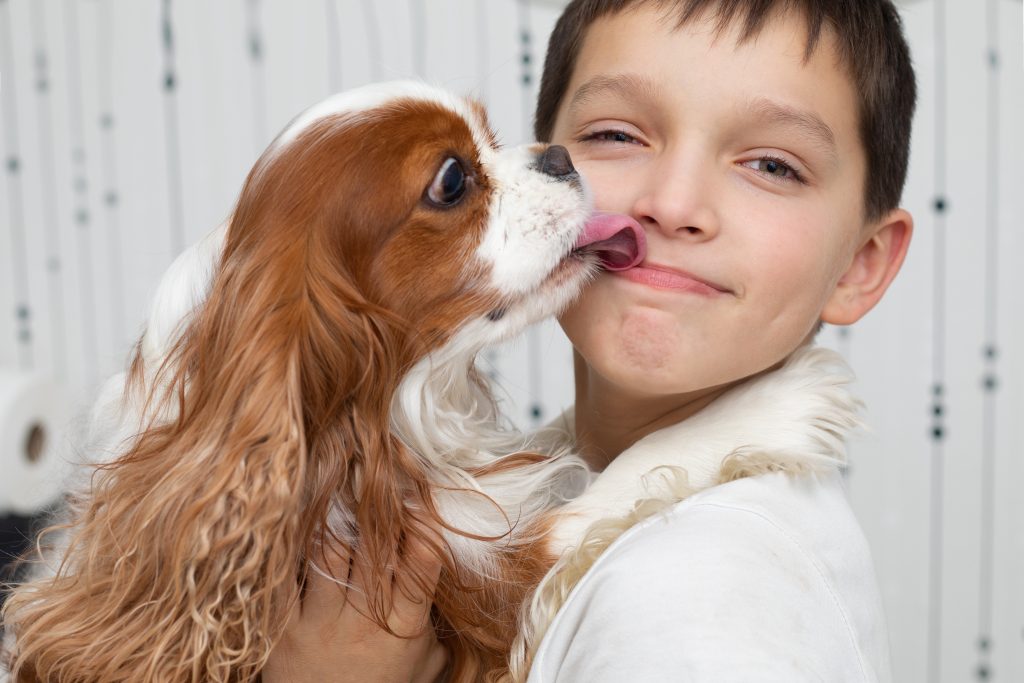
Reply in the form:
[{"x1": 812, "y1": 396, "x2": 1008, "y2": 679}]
[{"x1": 552, "y1": 5, "x2": 905, "y2": 394}]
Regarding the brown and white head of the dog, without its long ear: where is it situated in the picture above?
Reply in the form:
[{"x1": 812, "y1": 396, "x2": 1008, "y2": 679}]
[{"x1": 234, "y1": 83, "x2": 630, "y2": 358}]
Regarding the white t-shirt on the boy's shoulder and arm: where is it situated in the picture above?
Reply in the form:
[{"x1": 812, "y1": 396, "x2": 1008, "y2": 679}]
[{"x1": 528, "y1": 470, "x2": 891, "y2": 683}]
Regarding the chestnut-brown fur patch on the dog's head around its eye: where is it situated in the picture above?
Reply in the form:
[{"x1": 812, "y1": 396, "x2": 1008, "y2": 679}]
[{"x1": 234, "y1": 99, "x2": 499, "y2": 355}]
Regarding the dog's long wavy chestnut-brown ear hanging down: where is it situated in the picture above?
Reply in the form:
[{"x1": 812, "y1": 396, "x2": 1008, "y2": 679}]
[{"x1": 5, "y1": 204, "x2": 442, "y2": 681}]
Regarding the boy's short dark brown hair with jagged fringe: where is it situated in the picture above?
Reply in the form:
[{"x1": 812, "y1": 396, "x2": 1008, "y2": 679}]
[{"x1": 534, "y1": 0, "x2": 916, "y2": 220}]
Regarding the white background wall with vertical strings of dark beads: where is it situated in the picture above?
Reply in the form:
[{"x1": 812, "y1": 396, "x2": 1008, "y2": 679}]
[{"x1": 0, "y1": 0, "x2": 1024, "y2": 682}]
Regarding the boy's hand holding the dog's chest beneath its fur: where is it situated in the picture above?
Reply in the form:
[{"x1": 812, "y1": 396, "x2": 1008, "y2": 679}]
[{"x1": 262, "y1": 532, "x2": 447, "y2": 683}]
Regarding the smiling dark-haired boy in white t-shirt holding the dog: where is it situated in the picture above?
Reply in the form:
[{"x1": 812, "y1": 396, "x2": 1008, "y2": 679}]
[{"x1": 266, "y1": 0, "x2": 915, "y2": 681}]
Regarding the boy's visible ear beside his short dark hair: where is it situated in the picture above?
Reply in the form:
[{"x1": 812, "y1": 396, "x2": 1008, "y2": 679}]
[{"x1": 821, "y1": 209, "x2": 913, "y2": 325}]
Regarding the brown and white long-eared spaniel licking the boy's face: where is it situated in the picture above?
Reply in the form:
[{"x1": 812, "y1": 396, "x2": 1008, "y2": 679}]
[{"x1": 4, "y1": 82, "x2": 644, "y2": 683}]
